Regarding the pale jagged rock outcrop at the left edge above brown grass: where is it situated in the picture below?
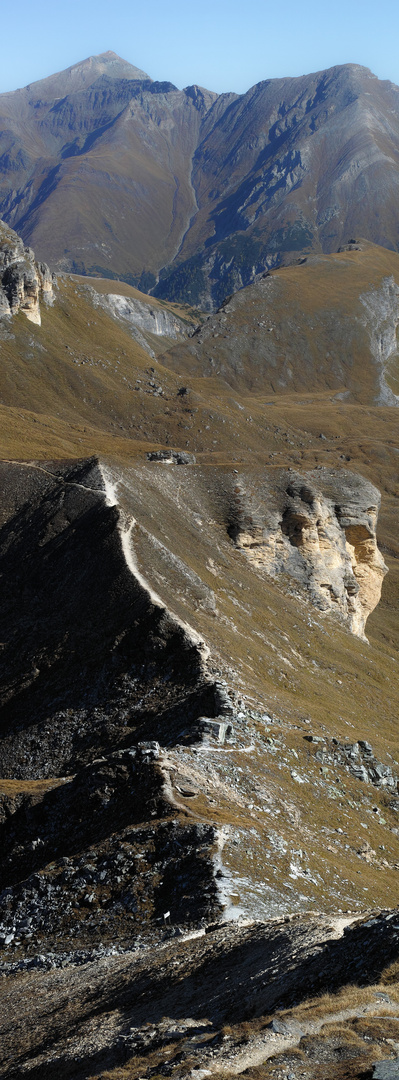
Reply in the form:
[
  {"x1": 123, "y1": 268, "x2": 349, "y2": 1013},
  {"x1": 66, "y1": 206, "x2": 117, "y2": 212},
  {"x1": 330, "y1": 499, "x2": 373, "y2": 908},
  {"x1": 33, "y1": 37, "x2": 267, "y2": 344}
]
[{"x1": 0, "y1": 220, "x2": 54, "y2": 326}]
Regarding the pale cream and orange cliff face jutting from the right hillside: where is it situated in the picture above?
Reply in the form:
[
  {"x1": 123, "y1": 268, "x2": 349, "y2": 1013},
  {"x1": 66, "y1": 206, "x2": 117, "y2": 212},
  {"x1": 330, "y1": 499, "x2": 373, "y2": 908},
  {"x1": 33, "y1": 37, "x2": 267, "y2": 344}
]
[{"x1": 229, "y1": 469, "x2": 387, "y2": 637}]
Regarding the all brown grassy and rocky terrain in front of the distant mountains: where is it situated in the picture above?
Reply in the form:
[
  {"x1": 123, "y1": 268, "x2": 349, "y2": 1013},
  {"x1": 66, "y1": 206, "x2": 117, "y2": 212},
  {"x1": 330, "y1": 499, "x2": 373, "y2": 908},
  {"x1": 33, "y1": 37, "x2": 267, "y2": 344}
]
[{"x1": 0, "y1": 226, "x2": 399, "y2": 1080}]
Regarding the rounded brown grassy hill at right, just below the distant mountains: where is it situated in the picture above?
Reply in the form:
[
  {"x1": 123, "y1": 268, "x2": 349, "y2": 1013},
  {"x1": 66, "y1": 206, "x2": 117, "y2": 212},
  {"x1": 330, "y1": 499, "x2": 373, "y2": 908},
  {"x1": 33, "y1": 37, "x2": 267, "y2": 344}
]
[{"x1": 162, "y1": 241, "x2": 399, "y2": 404}]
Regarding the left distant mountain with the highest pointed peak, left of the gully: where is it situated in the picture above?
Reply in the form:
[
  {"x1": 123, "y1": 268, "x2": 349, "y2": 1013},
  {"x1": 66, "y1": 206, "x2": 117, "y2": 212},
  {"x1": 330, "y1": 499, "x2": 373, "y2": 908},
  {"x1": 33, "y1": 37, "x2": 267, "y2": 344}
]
[{"x1": 0, "y1": 54, "x2": 215, "y2": 284}]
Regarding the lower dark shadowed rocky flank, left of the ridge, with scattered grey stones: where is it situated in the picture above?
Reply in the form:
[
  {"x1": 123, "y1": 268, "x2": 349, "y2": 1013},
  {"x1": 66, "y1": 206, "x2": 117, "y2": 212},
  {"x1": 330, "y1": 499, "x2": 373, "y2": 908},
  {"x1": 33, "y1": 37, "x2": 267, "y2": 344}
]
[{"x1": 0, "y1": 744, "x2": 221, "y2": 955}]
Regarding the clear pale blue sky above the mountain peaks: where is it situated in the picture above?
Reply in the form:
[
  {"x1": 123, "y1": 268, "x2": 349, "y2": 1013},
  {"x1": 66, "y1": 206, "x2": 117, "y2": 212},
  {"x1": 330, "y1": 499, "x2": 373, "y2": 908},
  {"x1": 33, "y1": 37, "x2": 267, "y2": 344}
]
[{"x1": 0, "y1": 0, "x2": 399, "y2": 93}]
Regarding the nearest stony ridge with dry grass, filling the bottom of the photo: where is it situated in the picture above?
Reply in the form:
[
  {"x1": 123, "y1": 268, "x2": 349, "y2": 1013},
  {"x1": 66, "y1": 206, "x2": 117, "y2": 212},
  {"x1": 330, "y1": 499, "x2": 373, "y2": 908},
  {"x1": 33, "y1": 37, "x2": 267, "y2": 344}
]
[{"x1": 0, "y1": 907, "x2": 399, "y2": 1080}]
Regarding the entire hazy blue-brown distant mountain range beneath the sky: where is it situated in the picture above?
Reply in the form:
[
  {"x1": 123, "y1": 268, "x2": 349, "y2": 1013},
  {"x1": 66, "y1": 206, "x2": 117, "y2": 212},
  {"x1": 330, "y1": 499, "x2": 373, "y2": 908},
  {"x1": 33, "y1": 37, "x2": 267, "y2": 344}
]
[{"x1": 0, "y1": 52, "x2": 399, "y2": 310}]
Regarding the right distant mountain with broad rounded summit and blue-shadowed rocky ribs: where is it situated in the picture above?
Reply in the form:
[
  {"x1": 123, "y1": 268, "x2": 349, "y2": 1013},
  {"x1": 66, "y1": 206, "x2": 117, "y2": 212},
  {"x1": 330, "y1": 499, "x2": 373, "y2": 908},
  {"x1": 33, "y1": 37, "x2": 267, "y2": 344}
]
[{"x1": 158, "y1": 64, "x2": 399, "y2": 308}]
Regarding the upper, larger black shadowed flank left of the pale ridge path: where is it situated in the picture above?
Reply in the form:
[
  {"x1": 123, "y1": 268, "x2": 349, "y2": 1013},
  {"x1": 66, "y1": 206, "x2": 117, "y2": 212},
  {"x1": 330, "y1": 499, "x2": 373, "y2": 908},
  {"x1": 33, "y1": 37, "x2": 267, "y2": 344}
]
[{"x1": 0, "y1": 459, "x2": 215, "y2": 778}]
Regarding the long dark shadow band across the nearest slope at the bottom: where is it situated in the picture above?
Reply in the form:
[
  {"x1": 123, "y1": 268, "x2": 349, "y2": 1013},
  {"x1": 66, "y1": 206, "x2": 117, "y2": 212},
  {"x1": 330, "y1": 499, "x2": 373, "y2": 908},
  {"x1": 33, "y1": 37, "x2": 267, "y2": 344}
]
[{"x1": 5, "y1": 913, "x2": 399, "y2": 1080}]
